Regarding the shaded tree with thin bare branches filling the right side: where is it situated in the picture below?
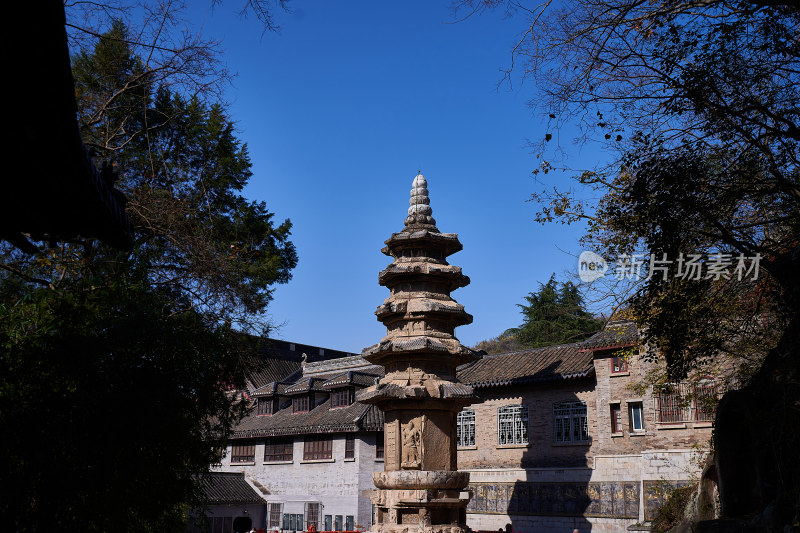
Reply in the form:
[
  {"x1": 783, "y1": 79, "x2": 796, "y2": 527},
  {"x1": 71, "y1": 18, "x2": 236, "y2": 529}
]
[{"x1": 458, "y1": 0, "x2": 800, "y2": 530}]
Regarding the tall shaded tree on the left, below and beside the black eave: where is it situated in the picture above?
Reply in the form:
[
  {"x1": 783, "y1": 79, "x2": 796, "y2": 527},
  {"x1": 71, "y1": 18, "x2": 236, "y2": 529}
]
[{"x1": 0, "y1": 11, "x2": 297, "y2": 531}]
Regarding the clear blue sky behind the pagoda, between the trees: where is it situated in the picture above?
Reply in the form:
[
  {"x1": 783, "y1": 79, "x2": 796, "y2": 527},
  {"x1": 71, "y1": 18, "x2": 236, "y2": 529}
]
[{"x1": 188, "y1": 0, "x2": 608, "y2": 352}]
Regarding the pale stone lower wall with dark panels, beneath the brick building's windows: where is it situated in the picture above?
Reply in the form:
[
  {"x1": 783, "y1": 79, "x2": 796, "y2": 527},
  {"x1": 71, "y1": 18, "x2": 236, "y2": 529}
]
[{"x1": 467, "y1": 449, "x2": 698, "y2": 532}]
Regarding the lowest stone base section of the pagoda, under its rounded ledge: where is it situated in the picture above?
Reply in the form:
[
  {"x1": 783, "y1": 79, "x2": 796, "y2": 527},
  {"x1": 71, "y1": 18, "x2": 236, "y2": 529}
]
[{"x1": 371, "y1": 489, "x2": 471, "y2": 533}]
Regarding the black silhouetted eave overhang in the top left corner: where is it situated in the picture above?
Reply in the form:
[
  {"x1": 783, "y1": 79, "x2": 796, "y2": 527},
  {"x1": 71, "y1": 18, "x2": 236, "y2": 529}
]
[{"x1": 0, "y1": 2, "x2": 132, "y2": 253}]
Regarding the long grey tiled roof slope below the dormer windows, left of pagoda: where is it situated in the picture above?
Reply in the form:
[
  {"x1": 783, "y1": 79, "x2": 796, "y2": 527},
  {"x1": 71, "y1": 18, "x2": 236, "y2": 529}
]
[{"x1": 233, "y1": 390, "x2": 383, "y2": 438}]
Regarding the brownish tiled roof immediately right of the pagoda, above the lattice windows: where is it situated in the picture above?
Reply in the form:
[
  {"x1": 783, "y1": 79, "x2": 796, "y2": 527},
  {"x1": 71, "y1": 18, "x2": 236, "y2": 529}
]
[{"x1": 457, "y1": 343, "x2": 594, "y2": 388}]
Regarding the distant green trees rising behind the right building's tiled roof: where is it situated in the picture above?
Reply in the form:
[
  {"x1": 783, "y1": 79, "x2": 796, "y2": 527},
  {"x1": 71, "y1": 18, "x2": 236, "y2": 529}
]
[{"x1": 475, "y1": 274, "x2": 602, "y2": 353}]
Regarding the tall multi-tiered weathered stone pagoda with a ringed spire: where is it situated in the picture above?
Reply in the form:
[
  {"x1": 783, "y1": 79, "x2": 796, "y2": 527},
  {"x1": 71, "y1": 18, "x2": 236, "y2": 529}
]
[{"x1": 358, "y1": 174, "x2": 477, "y2": 533}]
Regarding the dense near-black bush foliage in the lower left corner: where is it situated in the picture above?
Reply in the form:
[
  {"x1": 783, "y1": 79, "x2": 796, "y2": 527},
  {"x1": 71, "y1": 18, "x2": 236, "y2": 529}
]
[{"x1": 0, "y1": 279, "x2": 250, "y2": 532}]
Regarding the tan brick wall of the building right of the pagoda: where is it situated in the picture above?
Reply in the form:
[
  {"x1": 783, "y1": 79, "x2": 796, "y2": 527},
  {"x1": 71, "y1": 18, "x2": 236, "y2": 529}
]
[{"x1": 458, "y1": 352, "x2": 712, "y2": 533}]
